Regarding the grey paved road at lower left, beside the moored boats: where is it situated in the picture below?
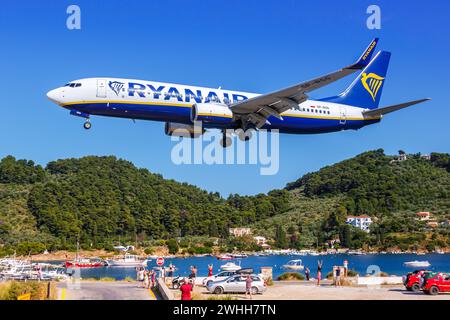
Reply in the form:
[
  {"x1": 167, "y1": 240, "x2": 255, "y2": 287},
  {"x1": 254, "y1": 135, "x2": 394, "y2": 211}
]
[{"x1": 58, "y1": 281, "x2": 156, "y2": 300}]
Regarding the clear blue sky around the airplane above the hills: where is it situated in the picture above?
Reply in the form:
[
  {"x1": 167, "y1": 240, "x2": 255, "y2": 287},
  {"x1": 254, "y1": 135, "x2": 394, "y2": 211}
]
[{"x1": 0, "y1": 0, "x2": 450, "y2": 196}]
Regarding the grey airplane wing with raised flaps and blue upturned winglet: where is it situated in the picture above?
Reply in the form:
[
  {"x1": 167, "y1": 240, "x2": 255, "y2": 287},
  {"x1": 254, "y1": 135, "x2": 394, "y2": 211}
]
[{"x1": 230, "y1": 38, "x2": 378, "y2": 128}]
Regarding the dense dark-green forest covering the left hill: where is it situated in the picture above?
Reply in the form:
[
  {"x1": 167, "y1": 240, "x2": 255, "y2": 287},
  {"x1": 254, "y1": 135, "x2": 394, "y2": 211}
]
[{"x1": 0, "y1": 156, "x2": 289, "y2": 252}]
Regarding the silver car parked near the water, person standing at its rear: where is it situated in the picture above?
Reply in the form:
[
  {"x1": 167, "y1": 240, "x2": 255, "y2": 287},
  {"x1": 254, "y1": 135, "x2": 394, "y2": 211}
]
[{"x1": 206, "y1": 274, "x2": 266, "y2": 294}]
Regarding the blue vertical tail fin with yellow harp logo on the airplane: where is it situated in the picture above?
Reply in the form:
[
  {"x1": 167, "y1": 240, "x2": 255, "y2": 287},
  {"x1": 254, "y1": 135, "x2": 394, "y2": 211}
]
[{"x1": 321, "y1": 51, "x2": 391, "y2": 109}]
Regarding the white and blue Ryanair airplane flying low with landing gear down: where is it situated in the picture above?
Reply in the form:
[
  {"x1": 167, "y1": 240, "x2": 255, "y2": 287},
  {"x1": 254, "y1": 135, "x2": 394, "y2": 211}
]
[{"x1": 47, "y1": 38, "x2": 430, "y2": 147}]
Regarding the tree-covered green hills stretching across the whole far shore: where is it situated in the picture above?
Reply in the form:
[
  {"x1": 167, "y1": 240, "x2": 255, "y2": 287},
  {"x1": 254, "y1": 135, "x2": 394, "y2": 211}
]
[{"x1": 0, "y1": 150, "x2": 450, "y2": 252}]
